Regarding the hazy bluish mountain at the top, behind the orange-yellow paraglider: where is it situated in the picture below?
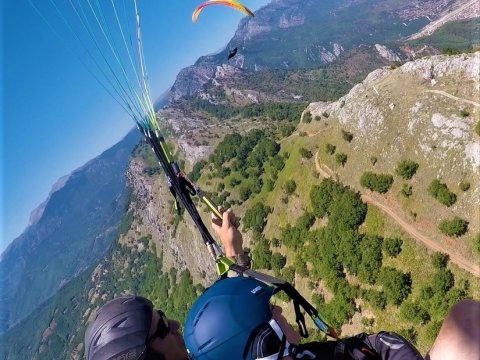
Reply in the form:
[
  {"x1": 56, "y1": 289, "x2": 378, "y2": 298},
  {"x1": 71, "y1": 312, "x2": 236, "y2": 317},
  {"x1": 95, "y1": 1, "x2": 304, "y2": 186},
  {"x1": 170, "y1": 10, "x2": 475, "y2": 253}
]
[{"x1": 170, "y1": 0, "x2": 462, "y2": 101}]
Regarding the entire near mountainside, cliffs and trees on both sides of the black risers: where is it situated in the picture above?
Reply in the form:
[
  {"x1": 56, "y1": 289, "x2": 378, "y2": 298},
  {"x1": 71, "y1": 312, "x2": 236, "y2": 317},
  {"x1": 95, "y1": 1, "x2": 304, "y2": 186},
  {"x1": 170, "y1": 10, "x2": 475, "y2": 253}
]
[{"x1": 0, "y1": 53, "x2": 480, "y2": 359}]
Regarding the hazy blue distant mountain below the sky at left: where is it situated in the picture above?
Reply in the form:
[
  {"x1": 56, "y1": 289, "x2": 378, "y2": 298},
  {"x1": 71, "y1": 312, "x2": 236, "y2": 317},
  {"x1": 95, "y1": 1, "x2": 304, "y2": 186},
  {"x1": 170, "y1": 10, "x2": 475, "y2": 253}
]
[{"x1": 0, "y1": 129, "x2": 139, "y2": 332}]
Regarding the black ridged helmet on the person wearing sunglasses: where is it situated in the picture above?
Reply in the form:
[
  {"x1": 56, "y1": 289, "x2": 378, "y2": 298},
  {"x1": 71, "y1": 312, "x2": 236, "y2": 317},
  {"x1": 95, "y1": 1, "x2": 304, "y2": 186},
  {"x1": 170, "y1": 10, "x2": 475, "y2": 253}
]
[{"x1": 85, "y1": 295, "x2": 153, "y2": 360}]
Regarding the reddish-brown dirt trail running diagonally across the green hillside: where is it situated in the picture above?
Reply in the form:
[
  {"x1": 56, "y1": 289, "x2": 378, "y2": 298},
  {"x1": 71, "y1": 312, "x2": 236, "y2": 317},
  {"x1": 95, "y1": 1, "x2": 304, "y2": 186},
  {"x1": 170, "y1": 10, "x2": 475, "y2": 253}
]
[{"x1": 315, "y1": 151, "x2": 480, "y2": 277}]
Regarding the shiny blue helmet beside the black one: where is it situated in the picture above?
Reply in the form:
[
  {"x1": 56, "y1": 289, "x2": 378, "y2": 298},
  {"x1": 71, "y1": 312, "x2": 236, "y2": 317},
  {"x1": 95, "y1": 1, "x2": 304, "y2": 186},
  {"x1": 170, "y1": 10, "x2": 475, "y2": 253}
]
[{"x1": 183, "y1": 276, "x2": 275, "y2": 360}]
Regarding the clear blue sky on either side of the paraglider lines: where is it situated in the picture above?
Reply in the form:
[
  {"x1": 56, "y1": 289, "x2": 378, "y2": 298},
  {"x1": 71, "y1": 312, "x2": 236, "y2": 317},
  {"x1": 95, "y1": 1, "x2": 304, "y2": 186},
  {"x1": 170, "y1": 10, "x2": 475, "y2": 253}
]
[{"x1": 0, "y1": 0, "x2": 269, "y2": 251}]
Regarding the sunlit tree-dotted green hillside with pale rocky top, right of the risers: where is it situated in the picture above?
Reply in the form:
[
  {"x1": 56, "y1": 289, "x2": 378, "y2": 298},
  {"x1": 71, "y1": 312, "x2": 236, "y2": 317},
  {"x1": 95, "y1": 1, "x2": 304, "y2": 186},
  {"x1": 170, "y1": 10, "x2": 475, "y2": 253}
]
[{"x1": 185, "y1": 53, "x2": 480, "y2": 351}]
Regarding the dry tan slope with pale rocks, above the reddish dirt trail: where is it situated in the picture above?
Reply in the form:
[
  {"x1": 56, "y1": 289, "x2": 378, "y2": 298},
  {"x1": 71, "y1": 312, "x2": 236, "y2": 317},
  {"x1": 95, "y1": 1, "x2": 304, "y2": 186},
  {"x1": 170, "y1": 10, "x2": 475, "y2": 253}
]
[{"x1": 304, "y1": 52, "x2": 480, "y2": 263}]
